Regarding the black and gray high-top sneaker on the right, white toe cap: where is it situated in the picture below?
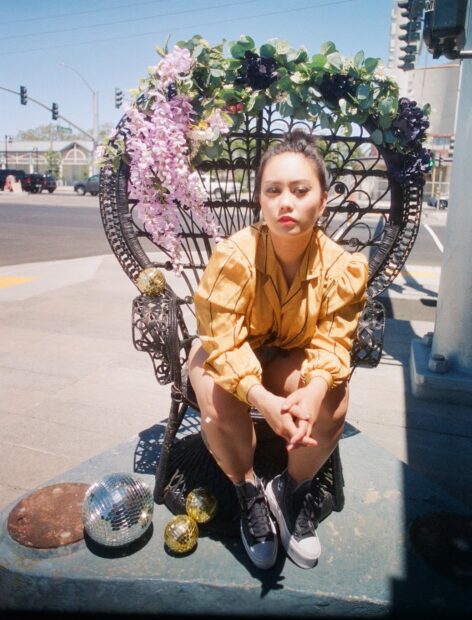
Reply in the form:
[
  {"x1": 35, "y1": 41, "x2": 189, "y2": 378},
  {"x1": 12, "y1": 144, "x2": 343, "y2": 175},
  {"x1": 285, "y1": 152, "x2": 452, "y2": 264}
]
[{"x1": 265, "y1": 470, "x2": 321, "y2": 568}]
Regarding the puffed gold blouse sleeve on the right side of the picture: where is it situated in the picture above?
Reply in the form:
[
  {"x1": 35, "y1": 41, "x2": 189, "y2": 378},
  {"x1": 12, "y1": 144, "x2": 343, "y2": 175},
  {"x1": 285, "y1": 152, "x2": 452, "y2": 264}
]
[{"x1": 302, "y1": 253, "x2": 368, "y2": 388}]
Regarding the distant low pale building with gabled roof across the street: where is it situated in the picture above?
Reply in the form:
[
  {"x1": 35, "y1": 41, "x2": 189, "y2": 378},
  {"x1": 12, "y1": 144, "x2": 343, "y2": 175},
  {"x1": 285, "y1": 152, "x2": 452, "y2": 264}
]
[{"x1": 0, "y1": 140, "x2": 94, "y2": 185}]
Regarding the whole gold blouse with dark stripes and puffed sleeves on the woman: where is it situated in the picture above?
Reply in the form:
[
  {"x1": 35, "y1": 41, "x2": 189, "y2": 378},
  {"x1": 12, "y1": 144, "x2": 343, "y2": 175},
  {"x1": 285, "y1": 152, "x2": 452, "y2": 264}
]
[{"x1": 194, "y1": 224, "x2": 368, "y2": 403}]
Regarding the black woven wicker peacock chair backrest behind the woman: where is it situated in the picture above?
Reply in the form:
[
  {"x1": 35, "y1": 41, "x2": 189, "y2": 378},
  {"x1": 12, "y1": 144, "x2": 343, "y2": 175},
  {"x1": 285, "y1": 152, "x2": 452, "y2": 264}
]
[{"x1": 100, "y1": 107, "x2": 422, "y2": 308}]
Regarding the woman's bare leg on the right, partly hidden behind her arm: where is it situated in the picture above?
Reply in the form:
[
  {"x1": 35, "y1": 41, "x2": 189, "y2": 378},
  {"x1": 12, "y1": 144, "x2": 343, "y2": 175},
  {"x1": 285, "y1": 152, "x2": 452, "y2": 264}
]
[{"x1": 263, "y1": 349, "x2": 349, "y2": 482}]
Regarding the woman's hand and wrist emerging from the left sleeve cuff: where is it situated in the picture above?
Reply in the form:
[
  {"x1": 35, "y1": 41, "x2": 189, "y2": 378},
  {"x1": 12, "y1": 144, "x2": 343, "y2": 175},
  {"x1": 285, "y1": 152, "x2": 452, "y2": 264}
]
[{"x1": 248, "y1": 385, "x2": 317, "y2": 449}]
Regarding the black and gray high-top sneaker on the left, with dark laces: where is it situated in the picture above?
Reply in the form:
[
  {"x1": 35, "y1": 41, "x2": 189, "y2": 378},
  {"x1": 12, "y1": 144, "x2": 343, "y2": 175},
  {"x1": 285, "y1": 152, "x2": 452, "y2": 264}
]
[{"x1": 235, "y1": 477, "x2": 278, "y2": 568}]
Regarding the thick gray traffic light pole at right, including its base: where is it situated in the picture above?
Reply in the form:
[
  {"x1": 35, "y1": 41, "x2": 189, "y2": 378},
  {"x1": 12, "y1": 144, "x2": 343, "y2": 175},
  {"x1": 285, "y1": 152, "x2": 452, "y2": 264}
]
[{"x1": 410, "y1": 7, "x2": 472, "y2": 404}]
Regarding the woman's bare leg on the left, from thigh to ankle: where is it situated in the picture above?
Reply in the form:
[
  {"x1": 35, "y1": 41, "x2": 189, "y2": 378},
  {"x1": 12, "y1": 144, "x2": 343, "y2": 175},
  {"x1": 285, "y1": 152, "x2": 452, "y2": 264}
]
[{"x1": 189, "y1": 344, "x2": 256, "y2": 483}]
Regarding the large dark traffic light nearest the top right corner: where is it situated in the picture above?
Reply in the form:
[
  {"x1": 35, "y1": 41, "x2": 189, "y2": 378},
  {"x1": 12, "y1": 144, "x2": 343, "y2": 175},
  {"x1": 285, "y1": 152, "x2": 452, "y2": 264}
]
[{"x1": 423, "y1": 0, "x2": 468, "y2": 60}]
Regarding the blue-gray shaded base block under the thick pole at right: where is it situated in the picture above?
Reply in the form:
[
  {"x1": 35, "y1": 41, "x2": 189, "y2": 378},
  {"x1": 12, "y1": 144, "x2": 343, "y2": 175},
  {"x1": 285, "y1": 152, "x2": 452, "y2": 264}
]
[{"x1": 410, "y1": 338, "x2": 472, "y2": 405}]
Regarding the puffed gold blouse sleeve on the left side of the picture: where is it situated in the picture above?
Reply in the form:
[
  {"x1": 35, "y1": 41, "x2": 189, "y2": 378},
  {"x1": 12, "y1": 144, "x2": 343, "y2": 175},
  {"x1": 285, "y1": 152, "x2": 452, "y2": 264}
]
[{"x1": 194, "y1": 240, "x2": 262, "y2": 403}]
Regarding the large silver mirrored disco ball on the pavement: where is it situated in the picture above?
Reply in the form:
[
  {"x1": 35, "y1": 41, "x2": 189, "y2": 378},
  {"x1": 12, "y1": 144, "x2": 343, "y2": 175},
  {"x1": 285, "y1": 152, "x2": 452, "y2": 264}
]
[{"x1": 82, "y1": 473, "x2": 154, "y2": 547}]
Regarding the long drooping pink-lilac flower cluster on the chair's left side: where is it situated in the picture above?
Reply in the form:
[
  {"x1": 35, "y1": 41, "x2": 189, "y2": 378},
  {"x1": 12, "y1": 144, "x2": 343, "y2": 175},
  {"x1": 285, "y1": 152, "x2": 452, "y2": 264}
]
[{"x1": 126, "y1": 90, "x2": 218, "y2": 273}]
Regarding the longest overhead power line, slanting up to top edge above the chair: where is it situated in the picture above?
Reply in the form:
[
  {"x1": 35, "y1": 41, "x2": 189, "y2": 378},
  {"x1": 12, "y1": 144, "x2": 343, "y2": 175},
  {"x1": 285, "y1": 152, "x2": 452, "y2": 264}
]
[{"x1": 3, "y1": 0, "x2": 370, "y2": 56}]
